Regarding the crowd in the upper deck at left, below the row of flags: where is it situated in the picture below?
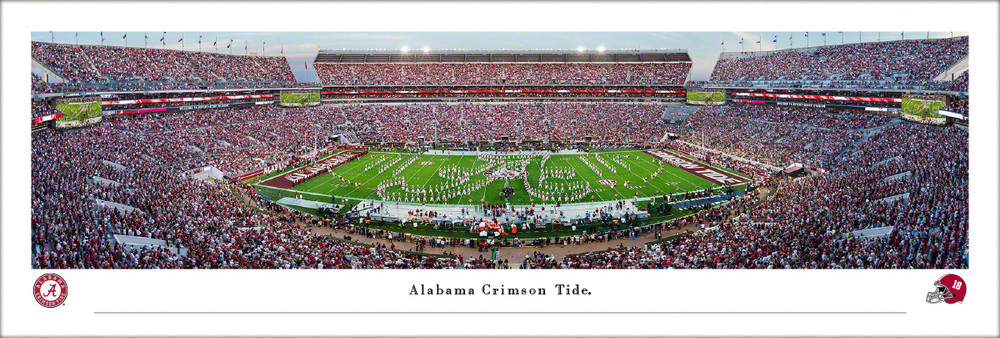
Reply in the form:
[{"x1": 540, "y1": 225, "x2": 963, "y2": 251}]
[{"x1": 31, "y1": 41, "x2": 310, "y2": 94}]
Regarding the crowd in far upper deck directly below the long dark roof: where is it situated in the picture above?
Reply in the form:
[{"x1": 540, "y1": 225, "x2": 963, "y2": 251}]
[{"x1": 315, "y1": 62, "x2": 691, "y2": 86}]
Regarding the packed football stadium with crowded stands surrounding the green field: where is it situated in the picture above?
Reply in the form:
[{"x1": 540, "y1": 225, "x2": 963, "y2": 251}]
[{"x1": 31, "y1": 33, "x2": 969, "y2": 269}]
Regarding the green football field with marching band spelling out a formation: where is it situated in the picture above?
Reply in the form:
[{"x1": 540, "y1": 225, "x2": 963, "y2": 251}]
[{"x1": 254, "y1": 150, "x2": 748, "y2": 205}]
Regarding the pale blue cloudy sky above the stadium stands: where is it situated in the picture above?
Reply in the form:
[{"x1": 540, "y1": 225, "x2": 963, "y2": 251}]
[{"x1": 31, "y1": 31, "x2": 967, "y2": 81}]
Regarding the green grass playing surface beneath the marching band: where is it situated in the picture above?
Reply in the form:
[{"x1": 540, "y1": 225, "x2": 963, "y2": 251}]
[{"x1": 249, "y1": 150, "x2": 744, "y2": 205}]
